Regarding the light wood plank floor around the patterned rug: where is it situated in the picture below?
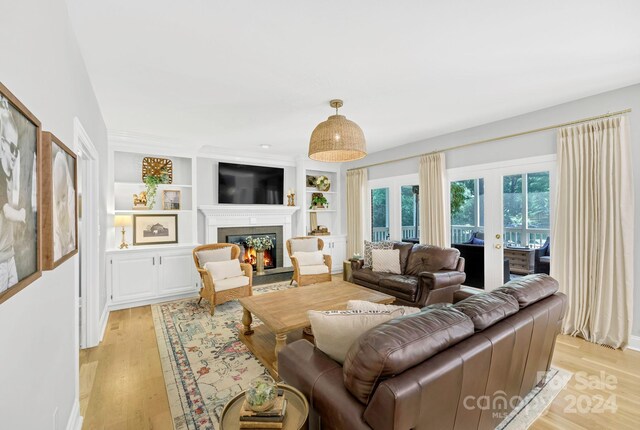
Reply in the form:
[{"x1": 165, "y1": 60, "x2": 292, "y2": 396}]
[{"x1": 80, "y1": 306, "x2": 640, "y2": 430}]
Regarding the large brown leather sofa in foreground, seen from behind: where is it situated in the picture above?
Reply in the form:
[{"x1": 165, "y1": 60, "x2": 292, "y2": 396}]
[{"x1": 279, "y1": 274, "x2": 566, "y2": 430}]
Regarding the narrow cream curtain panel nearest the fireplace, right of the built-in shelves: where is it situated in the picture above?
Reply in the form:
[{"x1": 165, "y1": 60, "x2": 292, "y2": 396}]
[{"x1": 347, "y1": 169, "x2": 368, "y2": 258}]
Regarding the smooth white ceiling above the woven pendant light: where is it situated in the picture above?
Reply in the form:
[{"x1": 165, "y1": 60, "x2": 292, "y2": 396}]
[{"x1": 67, "y1": 0, "x2": 640, "y2": 155}]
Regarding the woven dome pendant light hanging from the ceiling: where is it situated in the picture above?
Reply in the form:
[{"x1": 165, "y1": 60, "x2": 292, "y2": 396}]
[{"x1": 309, "y1": 100, "x2": 367, "y2": 163}]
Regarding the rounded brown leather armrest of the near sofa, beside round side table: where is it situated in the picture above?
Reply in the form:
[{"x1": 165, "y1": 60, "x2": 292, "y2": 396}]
[{"x1": 278, "y1": 339, "x2": 371, "y2": 430}]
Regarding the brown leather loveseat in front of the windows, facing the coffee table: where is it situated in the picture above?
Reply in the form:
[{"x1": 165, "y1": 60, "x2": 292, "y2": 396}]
[{"x1": 351, "y1": 242, "x2": 465, "y2": 307}]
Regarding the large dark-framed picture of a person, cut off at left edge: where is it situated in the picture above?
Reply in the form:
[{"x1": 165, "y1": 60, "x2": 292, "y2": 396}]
[{"x1": 0, "y1": 83, "x2": 42, "y2": 303}]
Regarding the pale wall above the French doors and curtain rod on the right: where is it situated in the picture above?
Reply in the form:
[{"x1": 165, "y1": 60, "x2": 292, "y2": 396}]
[{"x1": 342, "y1": 84, "x2": 640, "y2": 335}]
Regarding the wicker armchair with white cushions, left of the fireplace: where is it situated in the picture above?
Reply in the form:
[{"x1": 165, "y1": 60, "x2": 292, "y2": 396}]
[{"x1": 193, "y1": 243, "x2": 253, "y2": 315}]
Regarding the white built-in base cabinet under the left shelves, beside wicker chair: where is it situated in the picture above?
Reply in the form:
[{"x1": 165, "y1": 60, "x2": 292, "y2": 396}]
[{"x1": 107, "y1": 245, "x2": 200, "y2": 309}]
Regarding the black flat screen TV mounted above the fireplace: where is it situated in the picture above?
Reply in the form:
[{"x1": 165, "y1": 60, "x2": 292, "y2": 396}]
[{"x1": 218, "y1": 163, "x2": 284, "y2": 205}]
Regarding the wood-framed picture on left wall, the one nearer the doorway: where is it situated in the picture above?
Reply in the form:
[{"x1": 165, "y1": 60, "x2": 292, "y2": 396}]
[{"x1": 40, "y1": 131, "x2": 78, "y2": 270}]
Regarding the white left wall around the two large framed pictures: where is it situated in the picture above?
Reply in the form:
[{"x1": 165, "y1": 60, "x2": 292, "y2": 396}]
[{"x1": 0, "y1": 0, "x2": 107, "y2": 430}]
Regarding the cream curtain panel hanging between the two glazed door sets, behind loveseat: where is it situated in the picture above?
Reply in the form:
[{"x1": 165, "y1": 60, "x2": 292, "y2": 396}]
[{"x1": 418, "y1": 152, "x2": 449, "y2": 247}]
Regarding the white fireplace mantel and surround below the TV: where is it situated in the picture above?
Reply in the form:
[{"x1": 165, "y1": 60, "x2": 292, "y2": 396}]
[{"x1": 198, "y1": 205, "x2": 300, "y2": 266}]
